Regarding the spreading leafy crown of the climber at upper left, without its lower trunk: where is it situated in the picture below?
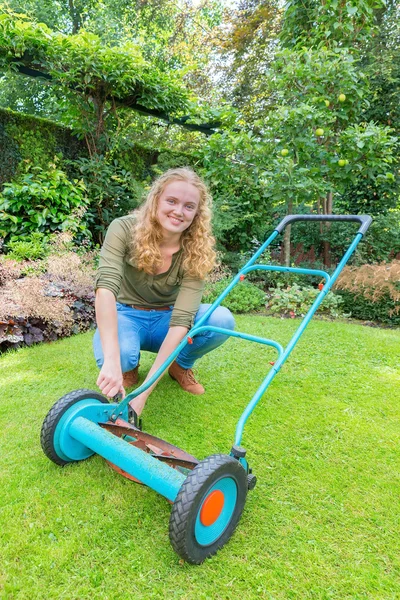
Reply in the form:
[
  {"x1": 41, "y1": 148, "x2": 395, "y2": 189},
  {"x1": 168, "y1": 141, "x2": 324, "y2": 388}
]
[{"x1": 0, "y1": 6, "x2": 188, "y2": 155}]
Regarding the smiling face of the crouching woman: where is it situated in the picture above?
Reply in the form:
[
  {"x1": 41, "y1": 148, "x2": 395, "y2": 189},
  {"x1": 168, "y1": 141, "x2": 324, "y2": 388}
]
[{"x1": 157, "y1": 181, "x2": 200, "y2": 237}]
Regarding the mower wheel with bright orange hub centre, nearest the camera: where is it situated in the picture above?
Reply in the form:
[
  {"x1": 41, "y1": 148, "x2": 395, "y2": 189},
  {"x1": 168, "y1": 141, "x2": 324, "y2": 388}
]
[{"x1": 169, "y1": 454, "x2": 247, "y2": 564}]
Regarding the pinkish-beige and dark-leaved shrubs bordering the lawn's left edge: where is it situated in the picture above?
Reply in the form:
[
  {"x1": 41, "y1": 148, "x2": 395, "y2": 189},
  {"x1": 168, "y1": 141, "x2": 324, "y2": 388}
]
[{"x1": 0, "y1": 240, "x2": 96, "y2": 351}]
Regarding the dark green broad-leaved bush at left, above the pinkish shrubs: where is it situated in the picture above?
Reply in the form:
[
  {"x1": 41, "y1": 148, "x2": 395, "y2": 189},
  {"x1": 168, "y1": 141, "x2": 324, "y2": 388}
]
[{"x1": 0, "y1": 163, "x2": 89, "y2": 244}]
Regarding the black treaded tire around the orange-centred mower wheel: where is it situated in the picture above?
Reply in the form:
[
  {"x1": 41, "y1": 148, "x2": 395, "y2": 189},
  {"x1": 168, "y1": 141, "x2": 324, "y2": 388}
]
[{"x1": 169, "y1": 454, "x2": 247, "y2": 565}]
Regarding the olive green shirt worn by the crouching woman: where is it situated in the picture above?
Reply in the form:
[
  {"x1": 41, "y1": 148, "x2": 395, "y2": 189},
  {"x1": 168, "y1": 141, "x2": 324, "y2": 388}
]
[{"x1": 95, "y1": 215, "x2": 204, "y2": 329}]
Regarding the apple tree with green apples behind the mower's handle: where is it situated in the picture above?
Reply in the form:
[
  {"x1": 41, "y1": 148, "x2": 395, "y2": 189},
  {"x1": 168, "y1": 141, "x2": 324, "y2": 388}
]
[{"x1": 254, "y1": 46, "x2": 398, "y2": 264}]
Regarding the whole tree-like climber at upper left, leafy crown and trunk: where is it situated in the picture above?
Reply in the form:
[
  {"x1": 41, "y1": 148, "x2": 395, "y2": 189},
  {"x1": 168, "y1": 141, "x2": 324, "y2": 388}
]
[{"x1": 0, "y1": 5, "x2": 193, "y2": 241}]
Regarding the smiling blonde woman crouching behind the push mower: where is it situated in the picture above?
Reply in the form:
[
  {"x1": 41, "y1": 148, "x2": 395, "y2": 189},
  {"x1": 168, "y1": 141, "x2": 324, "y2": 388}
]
[{"x1": 93, "y1": 167, "x2": 234, "y2": 422}]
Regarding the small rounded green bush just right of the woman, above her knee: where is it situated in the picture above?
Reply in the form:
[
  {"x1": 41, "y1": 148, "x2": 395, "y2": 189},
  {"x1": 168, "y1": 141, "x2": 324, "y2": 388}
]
[{"x1": 203, "y1": 279, "x2": 265, "y2": 313}]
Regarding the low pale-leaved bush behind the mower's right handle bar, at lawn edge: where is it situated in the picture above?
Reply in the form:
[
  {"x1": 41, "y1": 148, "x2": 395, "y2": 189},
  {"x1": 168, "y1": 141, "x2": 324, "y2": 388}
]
[{"x1": 267, "y1": 283, "x2": 343, "y2": 318}]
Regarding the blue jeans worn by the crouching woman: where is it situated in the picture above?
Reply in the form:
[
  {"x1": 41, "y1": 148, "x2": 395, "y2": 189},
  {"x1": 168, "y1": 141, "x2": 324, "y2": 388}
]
[{"x1": 93, "y1": 302, "x2": 235, "y2": 373}]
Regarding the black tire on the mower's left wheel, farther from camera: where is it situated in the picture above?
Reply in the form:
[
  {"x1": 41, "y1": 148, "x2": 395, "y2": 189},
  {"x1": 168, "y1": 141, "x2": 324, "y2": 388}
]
[{"x1": 40, "y1": 389, "x2": 108, "y2": 467}]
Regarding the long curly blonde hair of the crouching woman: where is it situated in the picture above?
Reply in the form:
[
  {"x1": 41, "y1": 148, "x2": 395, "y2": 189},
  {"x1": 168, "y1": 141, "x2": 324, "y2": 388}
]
[{"x1": 130, "y1": 167, "x2": 216, "y2": 279}]
